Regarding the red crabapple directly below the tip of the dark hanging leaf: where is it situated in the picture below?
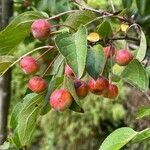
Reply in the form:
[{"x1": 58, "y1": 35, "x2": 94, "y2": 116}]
[{"x1": 88, "y1": 76, "x2": 109, "y2": 95}]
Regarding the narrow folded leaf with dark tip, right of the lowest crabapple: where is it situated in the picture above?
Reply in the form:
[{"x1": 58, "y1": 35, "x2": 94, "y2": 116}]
[{"x1": 66, "y1": 77, "x2": 84, "y2": 113}]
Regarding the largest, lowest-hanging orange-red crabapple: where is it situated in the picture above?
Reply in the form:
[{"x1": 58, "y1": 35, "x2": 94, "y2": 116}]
[{"x1": 50, "y1": 89, "x2": 73, "y2": 111}]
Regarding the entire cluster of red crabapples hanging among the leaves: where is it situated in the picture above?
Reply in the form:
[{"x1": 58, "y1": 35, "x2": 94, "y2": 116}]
[{"x1": 20, "y1": 19, "x2": 133, "y2": 111}]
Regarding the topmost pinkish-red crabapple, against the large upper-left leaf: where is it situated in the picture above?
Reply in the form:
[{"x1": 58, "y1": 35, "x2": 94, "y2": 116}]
[{"x1": 31, "y1": 19, "x2": 50, "y2": 40}]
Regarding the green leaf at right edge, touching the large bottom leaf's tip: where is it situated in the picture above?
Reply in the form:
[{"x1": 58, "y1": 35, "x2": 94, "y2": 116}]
[{"x1": 132, "y1": 128, "x2": 150, "y2": 143}]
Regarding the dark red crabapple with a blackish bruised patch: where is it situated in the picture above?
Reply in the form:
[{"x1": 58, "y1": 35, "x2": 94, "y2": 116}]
[{"x1": 73, "y1": 79, "x2": 88, "y2": 98}]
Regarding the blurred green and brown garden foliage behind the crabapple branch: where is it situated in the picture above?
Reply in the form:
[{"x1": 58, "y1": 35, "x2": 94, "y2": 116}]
[{"x1": 1, "y1": 0, "x2": 150, "y2": 150}]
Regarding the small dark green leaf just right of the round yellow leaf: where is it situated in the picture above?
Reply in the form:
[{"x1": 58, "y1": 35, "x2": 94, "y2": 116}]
[{"x1": 97, "y1": 21, "x2": 112, "y2": 38}]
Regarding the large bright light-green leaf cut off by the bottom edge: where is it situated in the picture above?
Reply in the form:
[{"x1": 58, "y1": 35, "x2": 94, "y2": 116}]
[{"x1": 99, "y1": 127, "x2": 137, "y2": 150}]
